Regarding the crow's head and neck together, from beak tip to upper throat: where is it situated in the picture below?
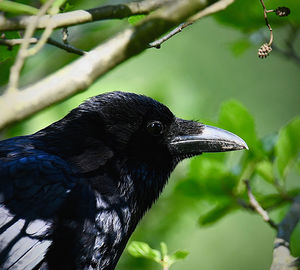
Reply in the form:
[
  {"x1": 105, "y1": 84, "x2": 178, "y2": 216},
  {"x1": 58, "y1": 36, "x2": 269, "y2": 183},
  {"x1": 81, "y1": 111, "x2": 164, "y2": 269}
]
[{"x1": 36, "y1": 92, "x2": 248, "y2": 208}]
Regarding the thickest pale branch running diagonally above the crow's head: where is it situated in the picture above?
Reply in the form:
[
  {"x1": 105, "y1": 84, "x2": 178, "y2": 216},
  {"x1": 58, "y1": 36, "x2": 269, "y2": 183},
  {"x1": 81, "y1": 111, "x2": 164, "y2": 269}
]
[{"x1": 0, "y1": 0, "x2": 232, "y2": 128}]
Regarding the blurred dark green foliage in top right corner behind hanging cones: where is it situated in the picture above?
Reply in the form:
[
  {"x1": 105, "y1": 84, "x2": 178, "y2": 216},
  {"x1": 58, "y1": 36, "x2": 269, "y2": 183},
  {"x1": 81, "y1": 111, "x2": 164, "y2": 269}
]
[{"x1": 213, "y1": 0, "x2": 300, "y2": 56}]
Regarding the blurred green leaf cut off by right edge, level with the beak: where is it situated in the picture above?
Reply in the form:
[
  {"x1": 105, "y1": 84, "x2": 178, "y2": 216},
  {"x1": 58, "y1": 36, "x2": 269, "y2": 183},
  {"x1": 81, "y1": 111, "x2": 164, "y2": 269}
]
[{"x1": 276, "y1": 116, "x2": 300, "y2": 179}]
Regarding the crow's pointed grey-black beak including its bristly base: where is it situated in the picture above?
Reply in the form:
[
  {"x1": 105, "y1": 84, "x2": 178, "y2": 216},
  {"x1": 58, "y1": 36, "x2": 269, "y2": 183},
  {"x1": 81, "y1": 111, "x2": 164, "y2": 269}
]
[{"x1": 169, "y1": 119, "x2": 249, "y2": 155}]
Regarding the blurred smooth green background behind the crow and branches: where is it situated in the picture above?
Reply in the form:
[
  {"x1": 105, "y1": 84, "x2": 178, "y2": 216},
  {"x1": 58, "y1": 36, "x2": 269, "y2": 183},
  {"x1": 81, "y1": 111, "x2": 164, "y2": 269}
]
[{"x1": 0, "y1": 1, "x2": 300, "y2": 270}]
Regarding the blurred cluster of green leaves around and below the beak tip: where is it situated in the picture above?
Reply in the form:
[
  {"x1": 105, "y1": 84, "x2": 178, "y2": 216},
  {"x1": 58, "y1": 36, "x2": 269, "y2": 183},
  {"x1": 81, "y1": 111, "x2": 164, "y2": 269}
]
[{"x1": 176, "y1": 100, "x2": 300, "y2": 229}]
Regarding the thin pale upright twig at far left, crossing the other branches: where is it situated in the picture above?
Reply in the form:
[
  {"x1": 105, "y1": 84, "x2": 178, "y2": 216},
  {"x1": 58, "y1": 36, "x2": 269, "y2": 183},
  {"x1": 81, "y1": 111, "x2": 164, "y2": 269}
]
[{"x1": 7, "y1": 0, "x2": 55, "y2": 92}]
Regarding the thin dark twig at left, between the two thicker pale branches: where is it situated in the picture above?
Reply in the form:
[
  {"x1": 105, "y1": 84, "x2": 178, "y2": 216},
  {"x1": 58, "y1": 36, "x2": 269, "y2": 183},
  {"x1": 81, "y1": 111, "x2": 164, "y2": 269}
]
[{"x1": 0, "y1": 37, "x2": 86, "y2": 55}]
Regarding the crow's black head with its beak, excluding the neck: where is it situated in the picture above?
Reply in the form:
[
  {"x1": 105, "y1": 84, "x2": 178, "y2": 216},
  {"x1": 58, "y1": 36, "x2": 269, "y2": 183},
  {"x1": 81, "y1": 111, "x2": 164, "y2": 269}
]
[{"x1": 75, "y1": 92, "x2": 248, "y2": 167}]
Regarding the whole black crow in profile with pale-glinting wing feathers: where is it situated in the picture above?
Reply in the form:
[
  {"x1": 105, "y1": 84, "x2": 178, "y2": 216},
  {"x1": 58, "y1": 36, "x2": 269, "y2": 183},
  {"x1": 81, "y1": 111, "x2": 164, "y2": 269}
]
[{"x1": 0, "y1": 92, "x2": 247, "y2": 270}]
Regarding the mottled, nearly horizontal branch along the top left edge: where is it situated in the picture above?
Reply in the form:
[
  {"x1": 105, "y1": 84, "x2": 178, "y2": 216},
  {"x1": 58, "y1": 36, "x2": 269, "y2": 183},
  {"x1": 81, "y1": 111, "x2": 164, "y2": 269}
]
[{"x1": 0, "y1": 0, "x2": 166, "y2": 31}]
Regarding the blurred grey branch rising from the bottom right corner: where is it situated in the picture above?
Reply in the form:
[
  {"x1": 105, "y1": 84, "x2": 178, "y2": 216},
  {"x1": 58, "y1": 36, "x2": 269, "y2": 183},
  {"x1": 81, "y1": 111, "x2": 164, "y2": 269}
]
[{"x1": 271, "y1": 195, "x2": 300, "y2": 270}]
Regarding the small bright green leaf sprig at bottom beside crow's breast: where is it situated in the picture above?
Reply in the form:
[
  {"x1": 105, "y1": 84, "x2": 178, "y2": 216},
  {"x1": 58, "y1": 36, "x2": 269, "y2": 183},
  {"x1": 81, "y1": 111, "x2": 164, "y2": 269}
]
[{"x1": 127, "y1": 241, "x2": 189, "y2": 269}]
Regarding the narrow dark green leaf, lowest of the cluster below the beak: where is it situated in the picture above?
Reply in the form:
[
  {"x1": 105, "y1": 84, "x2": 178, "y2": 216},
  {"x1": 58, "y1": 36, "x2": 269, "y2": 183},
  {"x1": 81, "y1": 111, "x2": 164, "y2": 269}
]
[{"x1": 198, "y1": 202, "x2": 233, "y2": 226}]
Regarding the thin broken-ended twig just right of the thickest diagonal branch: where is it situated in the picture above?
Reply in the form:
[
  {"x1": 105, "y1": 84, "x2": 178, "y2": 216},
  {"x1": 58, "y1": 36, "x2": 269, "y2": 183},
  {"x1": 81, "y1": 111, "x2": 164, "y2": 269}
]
[{"x1": 149, "y1": 0, "x2": 234, "y2": 49}]
